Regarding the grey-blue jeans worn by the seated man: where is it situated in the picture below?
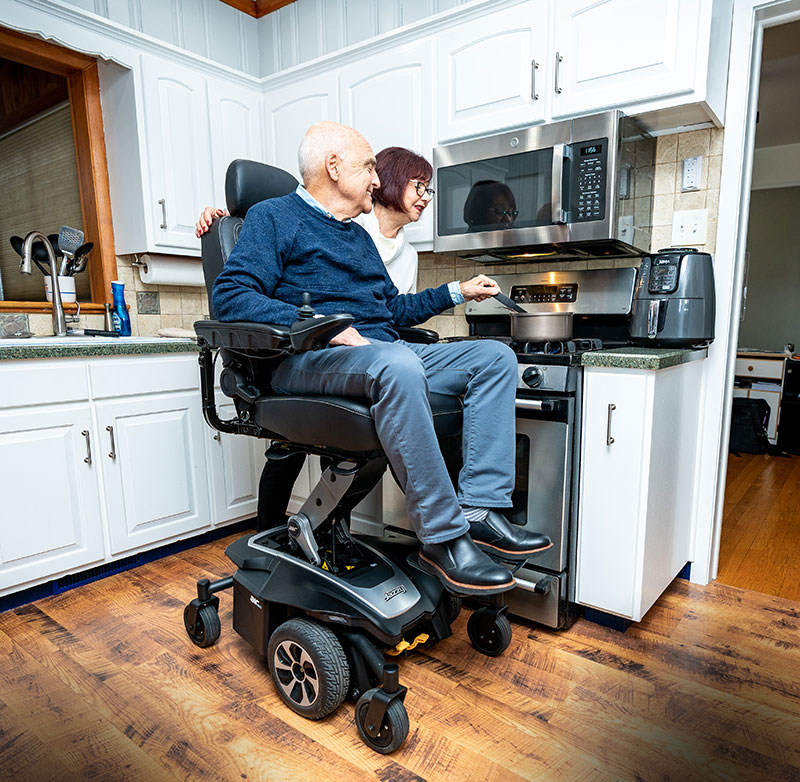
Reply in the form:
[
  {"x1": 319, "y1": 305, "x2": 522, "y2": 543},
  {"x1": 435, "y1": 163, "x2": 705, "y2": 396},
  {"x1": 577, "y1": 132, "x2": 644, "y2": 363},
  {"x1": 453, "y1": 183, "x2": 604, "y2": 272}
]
[{"x1": 272, "y1": 340, "x2": 517, "y2": 543}]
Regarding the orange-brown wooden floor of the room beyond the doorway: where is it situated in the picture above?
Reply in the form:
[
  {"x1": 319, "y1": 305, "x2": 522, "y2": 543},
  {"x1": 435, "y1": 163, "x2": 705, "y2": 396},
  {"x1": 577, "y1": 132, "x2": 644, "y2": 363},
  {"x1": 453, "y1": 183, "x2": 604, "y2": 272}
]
[{"x1": 717, "y1": 454, "x2": 800, "y2": 600}]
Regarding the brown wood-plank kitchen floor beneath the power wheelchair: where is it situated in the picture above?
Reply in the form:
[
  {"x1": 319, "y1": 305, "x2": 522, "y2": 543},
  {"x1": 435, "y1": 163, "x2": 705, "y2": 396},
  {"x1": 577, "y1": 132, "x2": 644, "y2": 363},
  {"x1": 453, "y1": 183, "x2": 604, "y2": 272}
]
[{"x1": 0, "y1": 541, "x2": 800, "y2": 782}]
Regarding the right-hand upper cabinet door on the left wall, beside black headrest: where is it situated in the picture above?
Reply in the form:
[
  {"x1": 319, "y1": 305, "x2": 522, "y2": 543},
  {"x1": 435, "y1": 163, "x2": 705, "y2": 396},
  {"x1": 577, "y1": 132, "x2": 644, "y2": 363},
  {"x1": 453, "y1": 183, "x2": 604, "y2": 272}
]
[{"x1": 208, "y1": 79, "x2": 264, "y2": 207}]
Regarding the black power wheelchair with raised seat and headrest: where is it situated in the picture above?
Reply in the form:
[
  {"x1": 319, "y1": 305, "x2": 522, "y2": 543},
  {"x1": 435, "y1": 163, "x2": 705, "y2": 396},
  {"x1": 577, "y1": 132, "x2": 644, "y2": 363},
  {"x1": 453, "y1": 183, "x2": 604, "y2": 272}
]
[{"x1": 184, "y1": 160, "x2": 511, "y2": 754}]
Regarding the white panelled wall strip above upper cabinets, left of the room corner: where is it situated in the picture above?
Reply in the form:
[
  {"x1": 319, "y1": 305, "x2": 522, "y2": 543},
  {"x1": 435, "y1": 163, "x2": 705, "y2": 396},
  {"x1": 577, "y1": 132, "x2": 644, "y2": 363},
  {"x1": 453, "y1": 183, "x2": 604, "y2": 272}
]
[{"x1": 53, "y1": 0, "x2": 260, "y2": 76}]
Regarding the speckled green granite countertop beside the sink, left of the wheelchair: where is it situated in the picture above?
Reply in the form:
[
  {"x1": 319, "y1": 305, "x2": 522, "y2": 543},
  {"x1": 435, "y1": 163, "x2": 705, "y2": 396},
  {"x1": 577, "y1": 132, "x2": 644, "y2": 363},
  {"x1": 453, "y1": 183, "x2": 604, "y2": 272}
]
[{"x1": 0, "y1": 337, "x2": 197, "y2": 361}]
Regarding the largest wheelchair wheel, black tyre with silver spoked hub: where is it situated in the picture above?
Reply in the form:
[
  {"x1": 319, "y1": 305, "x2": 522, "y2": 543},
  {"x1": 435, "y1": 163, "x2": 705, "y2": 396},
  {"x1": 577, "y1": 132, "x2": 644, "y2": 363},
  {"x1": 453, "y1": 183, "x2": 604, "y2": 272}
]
[{"x1": 267, "y1": 619, "x2": 350, "y2": 720}]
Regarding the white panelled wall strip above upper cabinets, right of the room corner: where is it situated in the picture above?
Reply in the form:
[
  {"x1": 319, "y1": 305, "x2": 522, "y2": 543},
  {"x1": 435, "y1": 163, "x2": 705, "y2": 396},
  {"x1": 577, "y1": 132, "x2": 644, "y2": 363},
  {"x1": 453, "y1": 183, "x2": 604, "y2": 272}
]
[{"x1": 258, "y1": 0, "x2": 467, "y2": 76}]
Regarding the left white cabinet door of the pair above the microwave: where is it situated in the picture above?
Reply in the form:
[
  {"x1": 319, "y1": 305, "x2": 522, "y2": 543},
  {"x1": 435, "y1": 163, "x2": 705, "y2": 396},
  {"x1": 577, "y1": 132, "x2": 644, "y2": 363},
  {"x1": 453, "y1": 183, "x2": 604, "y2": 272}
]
[{"x1": 437, "y1": 0, "x2": 551, "y2": 143}]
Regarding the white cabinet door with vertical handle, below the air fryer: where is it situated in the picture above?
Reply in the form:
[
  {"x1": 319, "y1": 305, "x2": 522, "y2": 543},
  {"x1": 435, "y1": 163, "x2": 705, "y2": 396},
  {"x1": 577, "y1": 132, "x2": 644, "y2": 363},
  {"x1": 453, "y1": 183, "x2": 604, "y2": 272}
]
[{"x1": 576, "y1": 371, "x2": 650, "y2": 620}]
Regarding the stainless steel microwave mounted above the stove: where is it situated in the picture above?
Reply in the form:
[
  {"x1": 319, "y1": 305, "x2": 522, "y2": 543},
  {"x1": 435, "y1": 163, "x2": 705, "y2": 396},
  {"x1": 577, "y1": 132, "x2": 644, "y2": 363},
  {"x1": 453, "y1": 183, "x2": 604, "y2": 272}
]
[{"x1": 433, "y1": 111, "x2": 655, "y2": 263}]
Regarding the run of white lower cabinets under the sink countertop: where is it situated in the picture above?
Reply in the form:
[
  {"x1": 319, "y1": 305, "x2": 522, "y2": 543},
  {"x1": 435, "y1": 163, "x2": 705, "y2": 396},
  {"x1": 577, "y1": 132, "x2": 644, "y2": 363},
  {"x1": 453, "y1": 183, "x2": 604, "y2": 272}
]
[{"x1": 0, "y1": 353, "x2": 265, "y2": 596}]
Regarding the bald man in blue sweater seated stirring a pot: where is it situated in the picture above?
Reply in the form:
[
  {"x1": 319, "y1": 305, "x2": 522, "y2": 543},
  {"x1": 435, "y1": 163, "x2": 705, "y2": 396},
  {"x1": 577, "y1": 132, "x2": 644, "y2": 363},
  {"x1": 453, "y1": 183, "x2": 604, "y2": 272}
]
[{"x1": 213, "y1": 122, "x2": 550, "y2": 595}]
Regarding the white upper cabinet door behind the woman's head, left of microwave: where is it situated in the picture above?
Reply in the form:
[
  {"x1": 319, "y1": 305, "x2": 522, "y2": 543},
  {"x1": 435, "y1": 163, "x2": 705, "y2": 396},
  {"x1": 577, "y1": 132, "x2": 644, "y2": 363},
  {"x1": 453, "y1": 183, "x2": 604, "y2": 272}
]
[{"x1": 339, "y1": 41, "x2": 434, "y2": 247}]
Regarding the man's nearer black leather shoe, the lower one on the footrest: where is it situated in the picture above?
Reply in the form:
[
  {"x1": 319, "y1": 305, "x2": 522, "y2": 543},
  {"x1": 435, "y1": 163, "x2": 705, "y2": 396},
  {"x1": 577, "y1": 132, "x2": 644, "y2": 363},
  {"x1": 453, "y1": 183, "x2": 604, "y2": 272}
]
[{"x1": 419, "y1": 533, "x2": 516, "y2": 595}]
